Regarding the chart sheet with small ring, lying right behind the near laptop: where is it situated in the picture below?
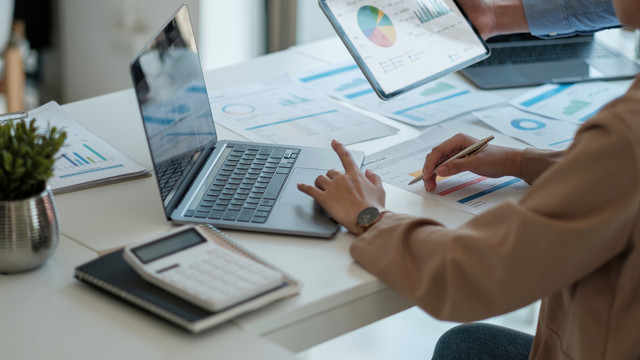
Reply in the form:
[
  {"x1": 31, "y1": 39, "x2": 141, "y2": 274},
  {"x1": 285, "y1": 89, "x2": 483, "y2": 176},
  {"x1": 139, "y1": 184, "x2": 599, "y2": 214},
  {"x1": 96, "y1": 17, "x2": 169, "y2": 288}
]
[{"x1": 209, "y1": 78, "x2": 398, "y2": 147}]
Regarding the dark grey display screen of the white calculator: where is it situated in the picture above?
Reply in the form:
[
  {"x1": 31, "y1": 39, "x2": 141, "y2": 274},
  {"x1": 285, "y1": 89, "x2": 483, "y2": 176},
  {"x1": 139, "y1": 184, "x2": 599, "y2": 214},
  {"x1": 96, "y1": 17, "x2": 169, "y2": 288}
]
[{"x1": 131, "y1": 229, "x2": 206, "y2": 264}]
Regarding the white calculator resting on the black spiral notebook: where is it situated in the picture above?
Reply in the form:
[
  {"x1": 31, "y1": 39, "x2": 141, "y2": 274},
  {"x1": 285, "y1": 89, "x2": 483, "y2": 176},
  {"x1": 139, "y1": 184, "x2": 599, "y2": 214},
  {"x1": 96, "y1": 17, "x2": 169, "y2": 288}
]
[{"x1": 123, "y1": 225, "x2": 284, "y2": 312}]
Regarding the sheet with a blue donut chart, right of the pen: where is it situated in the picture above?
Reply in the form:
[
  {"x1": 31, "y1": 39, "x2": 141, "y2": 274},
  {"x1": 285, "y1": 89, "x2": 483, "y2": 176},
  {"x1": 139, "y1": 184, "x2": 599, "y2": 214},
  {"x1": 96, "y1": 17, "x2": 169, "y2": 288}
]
[{"x1": 473, "y1": 106, "x2": 580, "y2": 150}]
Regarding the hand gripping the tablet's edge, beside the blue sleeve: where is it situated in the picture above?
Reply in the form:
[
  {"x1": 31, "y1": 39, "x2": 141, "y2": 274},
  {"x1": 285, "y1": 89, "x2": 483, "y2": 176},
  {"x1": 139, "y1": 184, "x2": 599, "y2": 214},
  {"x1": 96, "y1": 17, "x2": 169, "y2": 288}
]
[{"x1": 458, "y1": 0, "x2": 529, "y2": 39}]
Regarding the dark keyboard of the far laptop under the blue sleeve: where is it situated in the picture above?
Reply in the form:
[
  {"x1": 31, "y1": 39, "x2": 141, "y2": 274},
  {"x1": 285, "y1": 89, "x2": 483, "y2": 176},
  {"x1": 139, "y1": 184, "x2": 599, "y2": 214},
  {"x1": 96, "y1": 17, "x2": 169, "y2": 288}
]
[{"x1": 473, "y1": 43, "x2": 617, "y2": 66}]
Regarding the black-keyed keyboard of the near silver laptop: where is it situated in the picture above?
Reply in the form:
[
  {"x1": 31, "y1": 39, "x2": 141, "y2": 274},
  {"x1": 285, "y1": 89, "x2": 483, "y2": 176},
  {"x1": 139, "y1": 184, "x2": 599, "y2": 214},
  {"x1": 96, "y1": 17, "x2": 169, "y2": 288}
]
[{"x1": 185, "y1": 144, "x2": 300, "y2": 223}]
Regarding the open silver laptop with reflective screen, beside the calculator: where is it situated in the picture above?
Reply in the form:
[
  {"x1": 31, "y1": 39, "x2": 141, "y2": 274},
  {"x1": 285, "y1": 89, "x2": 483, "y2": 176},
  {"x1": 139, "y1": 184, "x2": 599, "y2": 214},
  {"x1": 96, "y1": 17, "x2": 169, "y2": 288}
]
[{"x1": 130, "y1": 5, "x2": 364, "y2": 238}]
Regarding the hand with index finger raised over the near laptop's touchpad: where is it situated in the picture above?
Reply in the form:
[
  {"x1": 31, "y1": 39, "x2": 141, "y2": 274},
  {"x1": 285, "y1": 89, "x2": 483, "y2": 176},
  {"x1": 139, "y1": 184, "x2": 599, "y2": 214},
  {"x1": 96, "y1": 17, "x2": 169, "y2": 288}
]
[{"x1": 298, "y1": 140, "x2": 385, "y2": 234}]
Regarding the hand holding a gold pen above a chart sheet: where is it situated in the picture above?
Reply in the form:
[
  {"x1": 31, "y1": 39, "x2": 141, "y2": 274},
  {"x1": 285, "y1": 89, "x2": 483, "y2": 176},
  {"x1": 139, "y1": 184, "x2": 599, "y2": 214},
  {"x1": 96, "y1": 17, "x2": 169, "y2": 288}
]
[{"x1": 422, "y1": 134, "x2": 522, "y2": 191}]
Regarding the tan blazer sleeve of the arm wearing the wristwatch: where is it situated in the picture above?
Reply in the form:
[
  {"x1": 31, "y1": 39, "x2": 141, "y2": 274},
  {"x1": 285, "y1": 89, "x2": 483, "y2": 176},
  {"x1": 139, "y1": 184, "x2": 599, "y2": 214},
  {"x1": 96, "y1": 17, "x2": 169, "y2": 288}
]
[{"x1": 350, "y1": 89, "x2": 640, "y2": 321}]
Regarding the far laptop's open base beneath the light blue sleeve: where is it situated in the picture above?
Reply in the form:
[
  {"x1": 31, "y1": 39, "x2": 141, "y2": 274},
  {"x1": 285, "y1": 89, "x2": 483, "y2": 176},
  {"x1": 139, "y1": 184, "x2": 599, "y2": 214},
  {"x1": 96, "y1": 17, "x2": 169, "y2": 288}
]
[{"x1": 460, "y1": 34, "x2": 640, "y2": 89}]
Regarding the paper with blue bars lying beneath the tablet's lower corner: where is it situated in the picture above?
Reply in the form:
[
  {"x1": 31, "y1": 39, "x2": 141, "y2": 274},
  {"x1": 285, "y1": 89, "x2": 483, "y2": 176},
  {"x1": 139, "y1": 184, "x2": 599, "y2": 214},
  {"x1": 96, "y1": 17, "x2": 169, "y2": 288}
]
[{"x1": 296, "y1": 62, "x2": 506, "y2": 126}]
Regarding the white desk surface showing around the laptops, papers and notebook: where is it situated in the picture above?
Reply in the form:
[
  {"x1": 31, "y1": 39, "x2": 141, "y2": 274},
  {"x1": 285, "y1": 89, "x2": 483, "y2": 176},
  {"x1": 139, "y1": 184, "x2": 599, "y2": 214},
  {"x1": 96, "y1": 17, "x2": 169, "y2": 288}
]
[{"x1": 0, "y1": 27, "x2": 633, "y2": 359}]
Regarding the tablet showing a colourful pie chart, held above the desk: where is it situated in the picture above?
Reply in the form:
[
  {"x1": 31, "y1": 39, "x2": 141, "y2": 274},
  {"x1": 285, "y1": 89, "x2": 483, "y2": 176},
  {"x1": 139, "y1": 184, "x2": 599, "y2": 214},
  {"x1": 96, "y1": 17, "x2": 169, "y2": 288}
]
[{"x1": 318, "y1": 0, "x2": 490, "y2": 100}]
